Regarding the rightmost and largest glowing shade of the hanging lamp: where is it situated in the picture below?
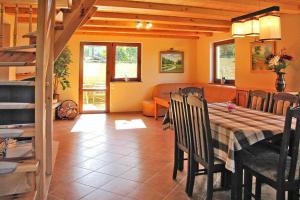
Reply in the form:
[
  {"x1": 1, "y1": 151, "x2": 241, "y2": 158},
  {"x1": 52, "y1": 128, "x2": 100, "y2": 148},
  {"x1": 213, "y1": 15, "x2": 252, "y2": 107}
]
[{"x1": 259, "y1": 15, "x2": 281, "y2": 40}]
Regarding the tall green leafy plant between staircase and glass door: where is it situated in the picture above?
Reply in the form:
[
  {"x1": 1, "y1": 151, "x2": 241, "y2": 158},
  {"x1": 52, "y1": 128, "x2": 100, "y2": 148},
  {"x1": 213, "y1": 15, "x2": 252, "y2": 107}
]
[{"x1": 53, "y1": 47, "x2": 72, "y2": 101}]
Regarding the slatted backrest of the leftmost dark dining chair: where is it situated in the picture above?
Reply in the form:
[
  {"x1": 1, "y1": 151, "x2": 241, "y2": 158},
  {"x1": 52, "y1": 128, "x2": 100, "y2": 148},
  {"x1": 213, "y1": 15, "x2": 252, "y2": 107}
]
[{"x1": 170, "y1": 93, "x2": 189, "y2": 152}]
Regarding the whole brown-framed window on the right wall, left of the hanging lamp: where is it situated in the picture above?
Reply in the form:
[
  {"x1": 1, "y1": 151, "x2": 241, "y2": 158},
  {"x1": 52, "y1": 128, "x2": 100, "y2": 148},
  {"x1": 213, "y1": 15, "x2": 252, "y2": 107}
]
[{"x1": 213, "y1": 40, "x2": 235, "y2": 85}]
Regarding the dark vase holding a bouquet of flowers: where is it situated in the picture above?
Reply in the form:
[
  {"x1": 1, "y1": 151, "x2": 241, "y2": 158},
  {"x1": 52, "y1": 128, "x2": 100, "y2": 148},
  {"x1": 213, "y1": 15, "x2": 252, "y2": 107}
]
[{"x1": 266, "y1": 49, "x2": 293, "y2": 92}]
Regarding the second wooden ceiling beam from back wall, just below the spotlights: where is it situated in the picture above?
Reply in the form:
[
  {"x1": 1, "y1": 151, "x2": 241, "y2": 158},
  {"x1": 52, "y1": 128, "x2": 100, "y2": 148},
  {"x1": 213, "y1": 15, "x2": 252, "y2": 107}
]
[{"x1": 79, "y1": 26, "x2": 212, "y2": 36}]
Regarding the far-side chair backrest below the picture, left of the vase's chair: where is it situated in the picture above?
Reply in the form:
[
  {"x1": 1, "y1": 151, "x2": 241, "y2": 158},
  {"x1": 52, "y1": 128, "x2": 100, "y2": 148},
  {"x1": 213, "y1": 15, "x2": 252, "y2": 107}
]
[{"x1": 247, "y1": 90, "x2": 270, "y2": 112}]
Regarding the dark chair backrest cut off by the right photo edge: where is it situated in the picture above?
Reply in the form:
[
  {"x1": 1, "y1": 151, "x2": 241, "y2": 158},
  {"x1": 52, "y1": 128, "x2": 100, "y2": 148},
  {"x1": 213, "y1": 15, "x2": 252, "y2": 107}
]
[{"x1": 277, "y1": 107, "x2": 300, "y2": 184}]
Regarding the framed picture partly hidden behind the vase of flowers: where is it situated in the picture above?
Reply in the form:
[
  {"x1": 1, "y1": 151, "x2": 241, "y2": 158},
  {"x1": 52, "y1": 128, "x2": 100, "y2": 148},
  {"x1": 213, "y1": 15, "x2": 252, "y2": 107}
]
[{"x1": 251, "y1": 41, "x2": 276, "y2": 72}]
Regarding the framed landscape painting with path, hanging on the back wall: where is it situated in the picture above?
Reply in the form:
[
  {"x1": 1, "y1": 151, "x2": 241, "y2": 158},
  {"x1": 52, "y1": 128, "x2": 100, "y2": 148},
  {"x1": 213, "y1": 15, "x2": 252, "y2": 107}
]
[{"x1": 159, "y1": 49, "x2": 184, "y2": 73}]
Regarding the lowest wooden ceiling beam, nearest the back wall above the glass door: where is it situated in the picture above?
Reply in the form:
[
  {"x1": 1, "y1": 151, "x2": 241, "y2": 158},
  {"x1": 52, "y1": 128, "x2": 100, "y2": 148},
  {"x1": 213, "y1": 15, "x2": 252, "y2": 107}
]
[{"x1": 75, "y1": 31, "x2": 199, "y2": 40}]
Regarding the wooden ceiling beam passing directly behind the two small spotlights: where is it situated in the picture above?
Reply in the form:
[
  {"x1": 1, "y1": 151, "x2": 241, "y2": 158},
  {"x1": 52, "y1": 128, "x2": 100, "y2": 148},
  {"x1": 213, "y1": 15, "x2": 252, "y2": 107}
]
[{"x1": 84, "y1": 20, "x2": 230, "y2": 32}]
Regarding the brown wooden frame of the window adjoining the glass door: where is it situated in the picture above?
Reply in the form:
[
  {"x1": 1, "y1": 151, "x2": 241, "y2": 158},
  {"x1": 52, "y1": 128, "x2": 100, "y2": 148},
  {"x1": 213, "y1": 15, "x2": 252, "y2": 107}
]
[{"x1": 110, "y1": 42, "x2": 142, "y2": 82}]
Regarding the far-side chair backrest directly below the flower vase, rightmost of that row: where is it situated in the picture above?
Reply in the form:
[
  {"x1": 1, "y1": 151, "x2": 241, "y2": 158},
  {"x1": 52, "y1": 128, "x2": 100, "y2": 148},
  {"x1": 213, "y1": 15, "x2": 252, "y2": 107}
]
[{"x1": 269, "y1": 92, "x2": 299, "y2": 116}]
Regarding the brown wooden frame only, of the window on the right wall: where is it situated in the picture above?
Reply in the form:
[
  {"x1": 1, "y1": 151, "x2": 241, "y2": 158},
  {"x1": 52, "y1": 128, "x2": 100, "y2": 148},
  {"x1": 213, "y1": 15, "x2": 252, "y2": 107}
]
[{"x1": 213, "y1": 39, "x2": 235, "y2": 85}]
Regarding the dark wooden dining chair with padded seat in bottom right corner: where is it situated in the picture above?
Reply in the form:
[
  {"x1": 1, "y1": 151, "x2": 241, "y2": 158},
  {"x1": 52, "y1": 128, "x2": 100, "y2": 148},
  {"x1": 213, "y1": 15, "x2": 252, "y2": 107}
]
[{"x1": 243, "y1": 107, "x2": 300, "y2": 200}]
